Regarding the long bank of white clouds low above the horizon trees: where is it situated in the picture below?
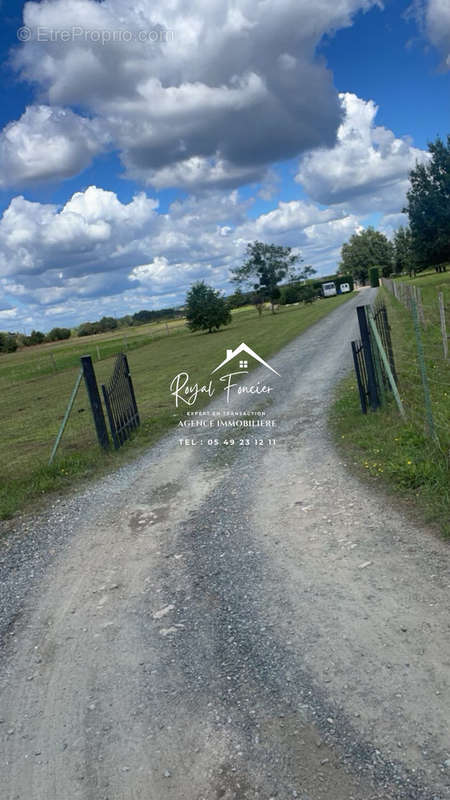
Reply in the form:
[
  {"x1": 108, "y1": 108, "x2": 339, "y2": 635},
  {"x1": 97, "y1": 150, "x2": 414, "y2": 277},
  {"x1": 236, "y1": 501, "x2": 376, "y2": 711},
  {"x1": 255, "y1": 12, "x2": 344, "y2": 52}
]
[{"x1": 0, "y1": 186, "x2": 359, "y2": 327}]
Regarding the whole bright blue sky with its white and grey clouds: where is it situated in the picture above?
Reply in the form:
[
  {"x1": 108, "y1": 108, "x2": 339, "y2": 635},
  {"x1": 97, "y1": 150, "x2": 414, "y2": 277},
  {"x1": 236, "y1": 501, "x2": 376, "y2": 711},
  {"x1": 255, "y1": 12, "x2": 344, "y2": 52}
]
[{"x1": 0, "y1": 0, "x2": 450, "y2": 330}]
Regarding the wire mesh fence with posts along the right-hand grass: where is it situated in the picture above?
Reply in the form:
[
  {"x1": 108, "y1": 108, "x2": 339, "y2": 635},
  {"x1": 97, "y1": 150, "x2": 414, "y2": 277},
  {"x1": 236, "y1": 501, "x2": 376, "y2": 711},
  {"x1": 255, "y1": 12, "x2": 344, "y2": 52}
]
[{"x1": 382, "y1": 278, "x2": 450, "y2": 454}]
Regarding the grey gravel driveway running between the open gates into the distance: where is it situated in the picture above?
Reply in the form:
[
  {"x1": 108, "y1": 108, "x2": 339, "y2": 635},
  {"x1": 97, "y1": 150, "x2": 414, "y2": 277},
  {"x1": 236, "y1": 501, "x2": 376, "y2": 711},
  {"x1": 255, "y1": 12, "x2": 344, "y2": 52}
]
[{"x1": 0, "y1": 289, "x2": 450, "y2": 800}]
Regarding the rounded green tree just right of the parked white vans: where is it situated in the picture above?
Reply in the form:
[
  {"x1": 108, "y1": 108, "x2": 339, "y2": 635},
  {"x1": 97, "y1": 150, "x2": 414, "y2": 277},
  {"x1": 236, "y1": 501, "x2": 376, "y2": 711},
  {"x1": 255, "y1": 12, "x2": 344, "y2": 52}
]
[{"x1": 339, "y1": 227, "x2": 394, "y2": 284}]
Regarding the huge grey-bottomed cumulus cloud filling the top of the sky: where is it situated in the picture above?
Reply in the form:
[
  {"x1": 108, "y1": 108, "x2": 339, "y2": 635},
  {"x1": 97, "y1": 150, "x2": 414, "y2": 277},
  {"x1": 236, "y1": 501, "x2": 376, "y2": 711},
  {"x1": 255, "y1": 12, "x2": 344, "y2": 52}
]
[{"x1": 5, "y1": 0, "x2": 378, "y2": 188}]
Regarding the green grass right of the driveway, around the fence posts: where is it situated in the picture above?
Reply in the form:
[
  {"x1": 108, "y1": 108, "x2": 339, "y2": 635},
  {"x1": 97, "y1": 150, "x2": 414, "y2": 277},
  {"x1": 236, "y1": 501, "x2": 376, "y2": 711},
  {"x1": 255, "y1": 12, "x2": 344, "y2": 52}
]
[{"x1": 331, "y1": 272, "x2": 450, "y2": 536}]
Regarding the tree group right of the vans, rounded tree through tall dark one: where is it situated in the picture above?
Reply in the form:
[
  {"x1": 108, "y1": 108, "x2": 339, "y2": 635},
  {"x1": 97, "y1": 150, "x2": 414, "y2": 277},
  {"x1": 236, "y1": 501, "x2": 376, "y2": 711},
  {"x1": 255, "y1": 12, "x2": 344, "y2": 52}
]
[{"x1": 339, "y1": 135, "x2": 450, "y2": 284}]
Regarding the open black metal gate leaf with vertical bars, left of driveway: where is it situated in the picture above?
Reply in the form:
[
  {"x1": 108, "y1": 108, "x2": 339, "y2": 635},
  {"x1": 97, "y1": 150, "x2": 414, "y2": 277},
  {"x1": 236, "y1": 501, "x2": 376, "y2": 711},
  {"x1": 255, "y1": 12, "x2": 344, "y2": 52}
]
[{"x1": 102, "y1": 353, "x2": 140, "y2": 450}]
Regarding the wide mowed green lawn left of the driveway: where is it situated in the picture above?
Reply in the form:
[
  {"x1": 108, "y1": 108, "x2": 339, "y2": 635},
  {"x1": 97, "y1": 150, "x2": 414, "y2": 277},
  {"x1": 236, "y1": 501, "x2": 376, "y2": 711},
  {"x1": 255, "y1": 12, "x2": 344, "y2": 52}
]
[{"x1": 0, "y1": 294, "x2": 353, "y2": 518}]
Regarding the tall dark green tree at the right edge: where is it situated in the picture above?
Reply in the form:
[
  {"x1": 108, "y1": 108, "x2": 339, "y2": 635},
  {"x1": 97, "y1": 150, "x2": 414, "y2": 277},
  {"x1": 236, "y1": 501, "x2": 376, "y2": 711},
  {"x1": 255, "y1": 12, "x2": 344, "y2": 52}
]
[{"x1": 404, "y1": 134, "x2": 450, "y2": 272}]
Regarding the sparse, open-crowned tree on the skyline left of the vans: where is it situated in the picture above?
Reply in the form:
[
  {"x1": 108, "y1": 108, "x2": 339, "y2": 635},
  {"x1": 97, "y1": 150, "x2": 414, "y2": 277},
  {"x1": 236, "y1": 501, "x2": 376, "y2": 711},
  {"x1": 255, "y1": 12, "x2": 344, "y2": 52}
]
[{"x1": 232, "y1": 241, "x2": 314, "y2": 312}]
